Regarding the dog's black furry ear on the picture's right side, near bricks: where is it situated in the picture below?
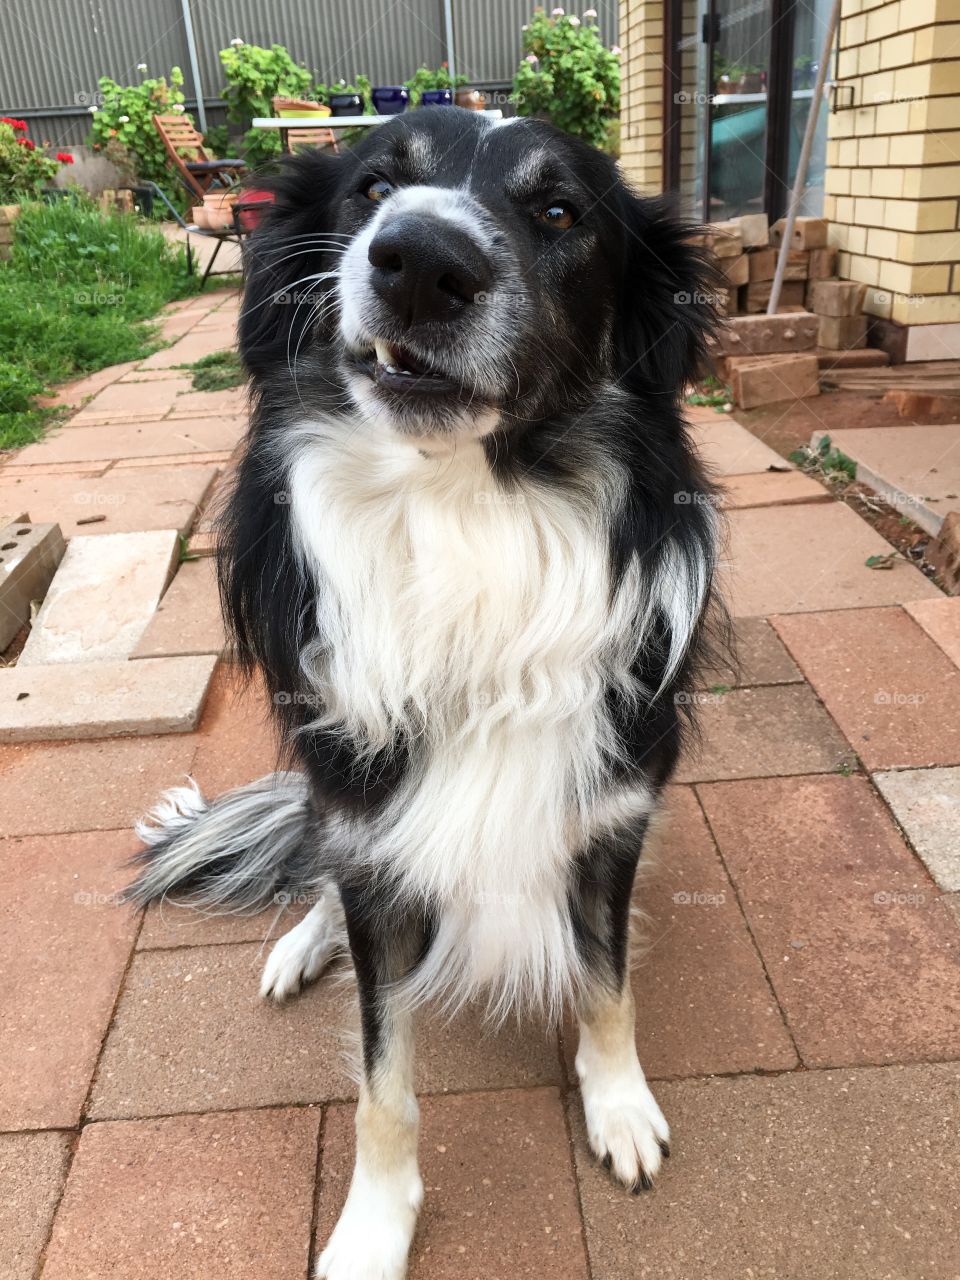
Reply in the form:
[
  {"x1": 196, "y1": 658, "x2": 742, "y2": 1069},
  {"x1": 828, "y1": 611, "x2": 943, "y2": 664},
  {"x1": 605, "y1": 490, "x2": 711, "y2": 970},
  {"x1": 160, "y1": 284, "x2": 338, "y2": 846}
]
[{"x1": 614, "y1": 187, "x2": 721, "y2": 398}]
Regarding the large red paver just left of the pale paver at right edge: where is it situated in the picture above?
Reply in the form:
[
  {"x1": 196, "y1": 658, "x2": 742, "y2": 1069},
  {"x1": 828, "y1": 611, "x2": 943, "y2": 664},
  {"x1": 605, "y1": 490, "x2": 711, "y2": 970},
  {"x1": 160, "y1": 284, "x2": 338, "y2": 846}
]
[{"x1": 698, "y1": 777, "x2": 960, "y2": 1066}]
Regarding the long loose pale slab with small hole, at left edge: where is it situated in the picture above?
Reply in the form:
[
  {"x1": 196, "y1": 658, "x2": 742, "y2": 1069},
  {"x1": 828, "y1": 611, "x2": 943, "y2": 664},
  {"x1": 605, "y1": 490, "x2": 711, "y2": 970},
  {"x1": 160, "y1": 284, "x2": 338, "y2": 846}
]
[{"x1": 0, "y1": 655, "x2": 216, "y2": 742}]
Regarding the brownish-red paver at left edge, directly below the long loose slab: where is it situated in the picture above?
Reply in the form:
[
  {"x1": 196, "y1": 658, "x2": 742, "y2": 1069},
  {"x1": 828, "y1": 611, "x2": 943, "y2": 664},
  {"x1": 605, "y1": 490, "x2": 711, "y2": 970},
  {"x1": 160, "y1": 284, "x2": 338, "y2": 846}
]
[{"x1": 0, "y1": 733, "x2": 197, "y2": 836}]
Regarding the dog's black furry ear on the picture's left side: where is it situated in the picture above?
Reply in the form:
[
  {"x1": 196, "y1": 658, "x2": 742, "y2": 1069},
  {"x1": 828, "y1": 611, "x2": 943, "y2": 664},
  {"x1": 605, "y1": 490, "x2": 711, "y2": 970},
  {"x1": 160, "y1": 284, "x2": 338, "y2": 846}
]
[{"x1": 238, "y1": 151, "x2": 351, "y2": 379}]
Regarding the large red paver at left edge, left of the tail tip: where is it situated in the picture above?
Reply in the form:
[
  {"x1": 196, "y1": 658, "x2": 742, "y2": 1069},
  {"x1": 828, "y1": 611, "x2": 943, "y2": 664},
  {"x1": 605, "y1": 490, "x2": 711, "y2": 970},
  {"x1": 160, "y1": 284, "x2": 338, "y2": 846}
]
[{"x1": 0, "y1": 832, "x2": 138, "y2": 1129}]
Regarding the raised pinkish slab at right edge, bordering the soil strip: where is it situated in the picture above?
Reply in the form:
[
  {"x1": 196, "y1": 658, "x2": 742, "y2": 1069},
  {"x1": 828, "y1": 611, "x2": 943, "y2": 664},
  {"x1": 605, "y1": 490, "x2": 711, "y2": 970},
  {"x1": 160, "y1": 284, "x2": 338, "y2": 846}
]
[{"x1": 813, "y1": 424, "x2": 960, "y2": 534}]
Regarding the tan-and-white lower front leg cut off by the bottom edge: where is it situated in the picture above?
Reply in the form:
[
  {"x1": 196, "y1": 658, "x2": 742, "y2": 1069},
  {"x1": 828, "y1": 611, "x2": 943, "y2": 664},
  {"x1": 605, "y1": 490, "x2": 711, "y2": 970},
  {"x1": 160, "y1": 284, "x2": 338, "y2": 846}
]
[{"x1": 316, "y1": 1009, "x2": 424, "y2": 1280}]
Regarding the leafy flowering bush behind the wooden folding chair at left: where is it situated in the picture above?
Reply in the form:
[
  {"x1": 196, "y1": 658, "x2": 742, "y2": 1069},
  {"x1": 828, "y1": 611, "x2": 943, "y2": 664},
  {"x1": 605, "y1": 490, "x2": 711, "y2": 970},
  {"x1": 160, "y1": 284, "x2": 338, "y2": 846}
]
[{"x1": 91, "y1": 64, "x2": 189, "y2": 187}]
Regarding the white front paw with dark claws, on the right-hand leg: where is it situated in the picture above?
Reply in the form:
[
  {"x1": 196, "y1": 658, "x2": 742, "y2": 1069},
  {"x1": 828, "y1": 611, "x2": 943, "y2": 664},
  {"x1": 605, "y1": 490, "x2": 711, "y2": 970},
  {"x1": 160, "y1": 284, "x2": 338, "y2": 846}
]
[{"x1": 581, "y1": 1064, "x2": 669, "y2": 1194}]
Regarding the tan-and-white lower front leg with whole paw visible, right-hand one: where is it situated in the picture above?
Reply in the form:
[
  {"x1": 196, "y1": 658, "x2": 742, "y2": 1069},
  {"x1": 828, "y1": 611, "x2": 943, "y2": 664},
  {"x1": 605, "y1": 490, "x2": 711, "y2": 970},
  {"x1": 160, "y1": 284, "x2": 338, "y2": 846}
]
[{"x1": 576, "y1": 978, "x2": 669, "y2": 1192}]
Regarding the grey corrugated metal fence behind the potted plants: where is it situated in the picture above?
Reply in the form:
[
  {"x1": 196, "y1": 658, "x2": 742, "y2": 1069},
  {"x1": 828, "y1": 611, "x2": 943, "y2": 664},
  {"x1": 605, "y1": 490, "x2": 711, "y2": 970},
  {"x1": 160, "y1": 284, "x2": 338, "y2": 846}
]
[{"x1": 0, "y1": 0, "x2": 617, "y2": 146}]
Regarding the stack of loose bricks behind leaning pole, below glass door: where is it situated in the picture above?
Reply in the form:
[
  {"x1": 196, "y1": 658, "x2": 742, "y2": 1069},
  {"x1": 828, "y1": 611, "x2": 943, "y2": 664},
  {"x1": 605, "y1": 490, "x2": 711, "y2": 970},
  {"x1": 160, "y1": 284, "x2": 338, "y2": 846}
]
[{"x1": 700, "y1": 214, "x2": 837, "y2": 315}]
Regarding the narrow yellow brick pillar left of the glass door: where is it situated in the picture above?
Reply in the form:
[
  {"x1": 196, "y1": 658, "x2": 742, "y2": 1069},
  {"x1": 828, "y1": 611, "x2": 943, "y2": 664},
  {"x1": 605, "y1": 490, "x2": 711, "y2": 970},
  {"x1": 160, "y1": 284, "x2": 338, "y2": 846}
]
[{"x1": 620, "y1": 0, "x2": 664, "y2": 193}]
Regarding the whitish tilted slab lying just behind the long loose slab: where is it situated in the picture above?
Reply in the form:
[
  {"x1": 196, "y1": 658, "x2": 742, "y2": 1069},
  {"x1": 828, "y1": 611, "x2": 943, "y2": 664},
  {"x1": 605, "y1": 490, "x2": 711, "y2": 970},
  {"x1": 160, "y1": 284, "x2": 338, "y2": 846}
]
[{"x1": 17, "y1": 529, "x2": 179, "y2": 668}]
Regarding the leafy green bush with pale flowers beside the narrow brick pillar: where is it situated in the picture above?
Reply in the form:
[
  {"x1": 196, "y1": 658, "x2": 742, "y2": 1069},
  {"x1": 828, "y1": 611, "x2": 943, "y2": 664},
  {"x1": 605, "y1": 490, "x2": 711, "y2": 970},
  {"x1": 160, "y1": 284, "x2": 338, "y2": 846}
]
[{"x1": 512, "y1": 9, "x2": 620, "y2": 147}]
